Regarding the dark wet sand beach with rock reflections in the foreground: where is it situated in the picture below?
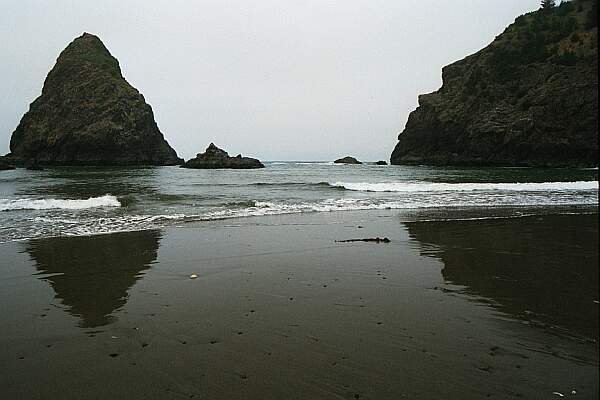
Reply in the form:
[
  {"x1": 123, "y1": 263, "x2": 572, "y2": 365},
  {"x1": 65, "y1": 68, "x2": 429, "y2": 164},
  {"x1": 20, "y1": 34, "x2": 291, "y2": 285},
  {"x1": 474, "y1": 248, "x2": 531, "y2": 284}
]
[{"x1": 0, "y1": 211, "x2": 598, "y2": 399}]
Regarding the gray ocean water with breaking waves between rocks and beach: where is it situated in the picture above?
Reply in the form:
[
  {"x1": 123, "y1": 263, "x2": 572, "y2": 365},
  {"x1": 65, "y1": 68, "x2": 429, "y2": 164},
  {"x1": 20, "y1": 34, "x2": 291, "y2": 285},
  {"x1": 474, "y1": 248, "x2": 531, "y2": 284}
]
[{"x1": 0, "y1": 162, "x2": 598, "y2": 242}]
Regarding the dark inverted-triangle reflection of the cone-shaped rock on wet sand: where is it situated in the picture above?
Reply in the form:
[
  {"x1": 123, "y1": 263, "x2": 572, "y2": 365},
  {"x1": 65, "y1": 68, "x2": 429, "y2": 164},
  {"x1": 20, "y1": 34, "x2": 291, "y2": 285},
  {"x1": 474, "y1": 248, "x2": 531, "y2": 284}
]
[{"x1": 24, "y1": 230, "x2": 161, "y2": 328}]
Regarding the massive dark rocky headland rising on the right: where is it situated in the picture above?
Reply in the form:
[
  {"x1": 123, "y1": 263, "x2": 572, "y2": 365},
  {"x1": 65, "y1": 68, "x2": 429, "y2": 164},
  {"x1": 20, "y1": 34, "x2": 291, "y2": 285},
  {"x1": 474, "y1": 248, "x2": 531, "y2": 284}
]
[{"x1": 391, "y1": 0, "x2": 598, "y2": 166}]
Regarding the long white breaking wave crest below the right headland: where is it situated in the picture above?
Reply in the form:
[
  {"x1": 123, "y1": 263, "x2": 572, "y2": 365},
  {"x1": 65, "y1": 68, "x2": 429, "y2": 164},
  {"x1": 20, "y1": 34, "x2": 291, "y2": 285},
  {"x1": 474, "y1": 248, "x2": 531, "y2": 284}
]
[{"x1": 330, "y1": 181, "x2": 598, "y2": 192}]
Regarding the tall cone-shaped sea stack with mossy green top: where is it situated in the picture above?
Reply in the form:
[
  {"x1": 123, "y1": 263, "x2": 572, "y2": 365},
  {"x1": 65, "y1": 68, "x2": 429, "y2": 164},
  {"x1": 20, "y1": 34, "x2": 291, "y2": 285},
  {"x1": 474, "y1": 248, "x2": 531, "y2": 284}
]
[{"x1": 10, "y1": 33, "x2": 183, "y2": 165}]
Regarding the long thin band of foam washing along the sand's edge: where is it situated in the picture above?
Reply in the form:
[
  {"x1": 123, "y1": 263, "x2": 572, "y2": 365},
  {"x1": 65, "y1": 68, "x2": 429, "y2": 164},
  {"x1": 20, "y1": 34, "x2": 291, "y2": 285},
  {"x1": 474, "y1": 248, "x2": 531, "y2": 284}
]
[{"x1": 0, "y1": 192, "x2": 597, "y2": 242}]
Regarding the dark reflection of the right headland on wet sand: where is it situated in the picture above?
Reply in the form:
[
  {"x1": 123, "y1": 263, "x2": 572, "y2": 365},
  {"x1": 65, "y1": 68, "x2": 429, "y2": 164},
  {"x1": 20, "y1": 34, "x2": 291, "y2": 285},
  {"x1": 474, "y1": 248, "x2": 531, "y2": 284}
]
[{"x1": 406, "y1": 215, "x2": 598, "y2": 340}]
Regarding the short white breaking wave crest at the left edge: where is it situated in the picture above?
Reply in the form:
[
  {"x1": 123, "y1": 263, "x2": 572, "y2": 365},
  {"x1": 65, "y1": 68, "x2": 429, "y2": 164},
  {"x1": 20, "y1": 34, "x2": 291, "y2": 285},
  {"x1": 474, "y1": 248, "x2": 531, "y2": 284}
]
[{"x1": 0, "y1": 194, "x2": 121, "y2": 211}]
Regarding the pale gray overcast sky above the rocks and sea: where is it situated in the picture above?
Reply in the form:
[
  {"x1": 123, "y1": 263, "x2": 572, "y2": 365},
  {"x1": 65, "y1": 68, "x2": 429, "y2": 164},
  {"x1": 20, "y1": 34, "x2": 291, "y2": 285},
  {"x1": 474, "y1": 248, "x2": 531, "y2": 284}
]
[{"x1": 0, "y1": 0, "x2": 539, "y2": 160}]
